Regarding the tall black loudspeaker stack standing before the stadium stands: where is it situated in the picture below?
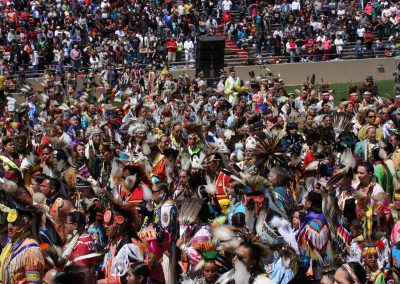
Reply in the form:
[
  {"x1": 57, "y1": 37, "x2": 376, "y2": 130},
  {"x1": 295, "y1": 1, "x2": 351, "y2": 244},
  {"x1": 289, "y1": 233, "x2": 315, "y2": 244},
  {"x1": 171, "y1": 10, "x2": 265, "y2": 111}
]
[{"x1": 196, "y1": 36, "x2": 225, "y2": 78}]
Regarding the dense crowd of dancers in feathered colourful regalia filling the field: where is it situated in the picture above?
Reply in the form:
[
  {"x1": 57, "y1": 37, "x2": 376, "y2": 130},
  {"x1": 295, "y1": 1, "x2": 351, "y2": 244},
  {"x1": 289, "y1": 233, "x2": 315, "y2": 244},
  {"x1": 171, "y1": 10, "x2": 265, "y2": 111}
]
[{"x1": 0, "y1": 58, "x2": 400, "y2": 284}]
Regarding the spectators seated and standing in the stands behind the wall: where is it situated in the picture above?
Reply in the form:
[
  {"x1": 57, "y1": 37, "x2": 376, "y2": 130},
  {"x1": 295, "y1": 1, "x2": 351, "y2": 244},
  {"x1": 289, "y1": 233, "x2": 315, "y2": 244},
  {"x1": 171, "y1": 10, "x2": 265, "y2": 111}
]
[{"x1": 0, "y1": 0, "x2": 400, "y2": 73}]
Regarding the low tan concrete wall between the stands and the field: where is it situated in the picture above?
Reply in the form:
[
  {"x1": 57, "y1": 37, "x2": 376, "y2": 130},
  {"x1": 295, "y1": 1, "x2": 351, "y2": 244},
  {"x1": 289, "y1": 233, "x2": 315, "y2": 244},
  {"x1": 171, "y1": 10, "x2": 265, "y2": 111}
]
[{"x1": 172, "y1": 57, "x2": 400, "y2": 86}]
